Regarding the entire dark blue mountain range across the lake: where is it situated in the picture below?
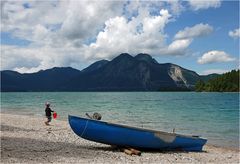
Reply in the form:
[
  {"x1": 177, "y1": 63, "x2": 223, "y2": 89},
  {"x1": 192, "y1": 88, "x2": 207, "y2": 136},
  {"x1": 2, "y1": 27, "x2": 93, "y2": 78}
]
[{"x1": 1, "y1": 53, "x2": 201, "y2": 91}]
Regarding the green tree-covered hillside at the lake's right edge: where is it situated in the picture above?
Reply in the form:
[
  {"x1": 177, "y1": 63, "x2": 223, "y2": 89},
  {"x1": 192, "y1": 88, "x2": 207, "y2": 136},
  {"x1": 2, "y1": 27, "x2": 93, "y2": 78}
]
[{"x1": 195, "y1": 70, "x2": 240, "y2": 92}]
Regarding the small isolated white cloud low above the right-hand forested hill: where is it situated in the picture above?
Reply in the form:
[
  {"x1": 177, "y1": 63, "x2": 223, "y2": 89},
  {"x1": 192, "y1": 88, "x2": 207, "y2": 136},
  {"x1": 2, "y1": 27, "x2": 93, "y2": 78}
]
[{"x1": 197, "y1": 50, "x2": 236, "y2": 64}]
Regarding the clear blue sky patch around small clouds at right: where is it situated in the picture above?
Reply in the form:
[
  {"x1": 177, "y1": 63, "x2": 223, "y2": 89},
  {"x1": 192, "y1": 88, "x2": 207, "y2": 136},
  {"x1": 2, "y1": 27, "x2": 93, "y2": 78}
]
[{"x1": 158, "y1": 1, "x2": 239, "y2": 73}]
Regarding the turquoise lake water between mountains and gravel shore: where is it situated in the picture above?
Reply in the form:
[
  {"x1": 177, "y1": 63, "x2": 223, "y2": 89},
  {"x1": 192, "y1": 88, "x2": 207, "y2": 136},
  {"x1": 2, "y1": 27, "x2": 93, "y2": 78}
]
[{"x1": 1, "y1": 92, "x2": 239, "y2": 147}]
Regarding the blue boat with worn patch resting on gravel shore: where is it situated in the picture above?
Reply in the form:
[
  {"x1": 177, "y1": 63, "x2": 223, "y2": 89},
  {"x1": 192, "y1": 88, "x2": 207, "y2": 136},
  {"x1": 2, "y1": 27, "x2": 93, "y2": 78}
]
[{"x1": 68, "y1": 115, "x2": 207, "y2": 151}]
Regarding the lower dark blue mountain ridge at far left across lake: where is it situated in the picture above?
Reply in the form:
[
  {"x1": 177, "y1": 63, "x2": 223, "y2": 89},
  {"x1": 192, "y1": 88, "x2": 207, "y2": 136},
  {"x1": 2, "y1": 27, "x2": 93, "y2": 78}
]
[{"x1": 1, "y1": 67, "x2": 81, "y2": 91}]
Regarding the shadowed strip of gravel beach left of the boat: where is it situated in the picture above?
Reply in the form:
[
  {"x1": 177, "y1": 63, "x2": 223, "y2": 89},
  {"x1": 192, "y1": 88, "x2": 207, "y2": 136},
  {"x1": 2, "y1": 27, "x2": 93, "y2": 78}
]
[{"x1": 1, "y1": 137, "x2": 118, "y2": 162}]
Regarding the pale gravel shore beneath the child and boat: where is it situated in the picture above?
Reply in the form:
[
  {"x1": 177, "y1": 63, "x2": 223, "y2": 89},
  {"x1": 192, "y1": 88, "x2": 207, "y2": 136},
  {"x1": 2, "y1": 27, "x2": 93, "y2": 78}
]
[{"x1": 1, "y1": 113, "x2": 240, "y2": 164}]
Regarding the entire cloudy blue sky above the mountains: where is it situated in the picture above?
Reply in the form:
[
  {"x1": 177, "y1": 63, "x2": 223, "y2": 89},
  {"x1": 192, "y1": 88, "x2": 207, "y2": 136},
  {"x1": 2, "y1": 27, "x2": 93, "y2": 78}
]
[{"x1": 1, "y1": 0, "x2": 240, "y2": 75}]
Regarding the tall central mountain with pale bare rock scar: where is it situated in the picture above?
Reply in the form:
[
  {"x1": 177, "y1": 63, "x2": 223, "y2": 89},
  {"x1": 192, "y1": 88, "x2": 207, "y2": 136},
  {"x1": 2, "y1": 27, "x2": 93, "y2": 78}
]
[{"x1": 67, "y1": 53, "x2": 200, "y2": 91}]
